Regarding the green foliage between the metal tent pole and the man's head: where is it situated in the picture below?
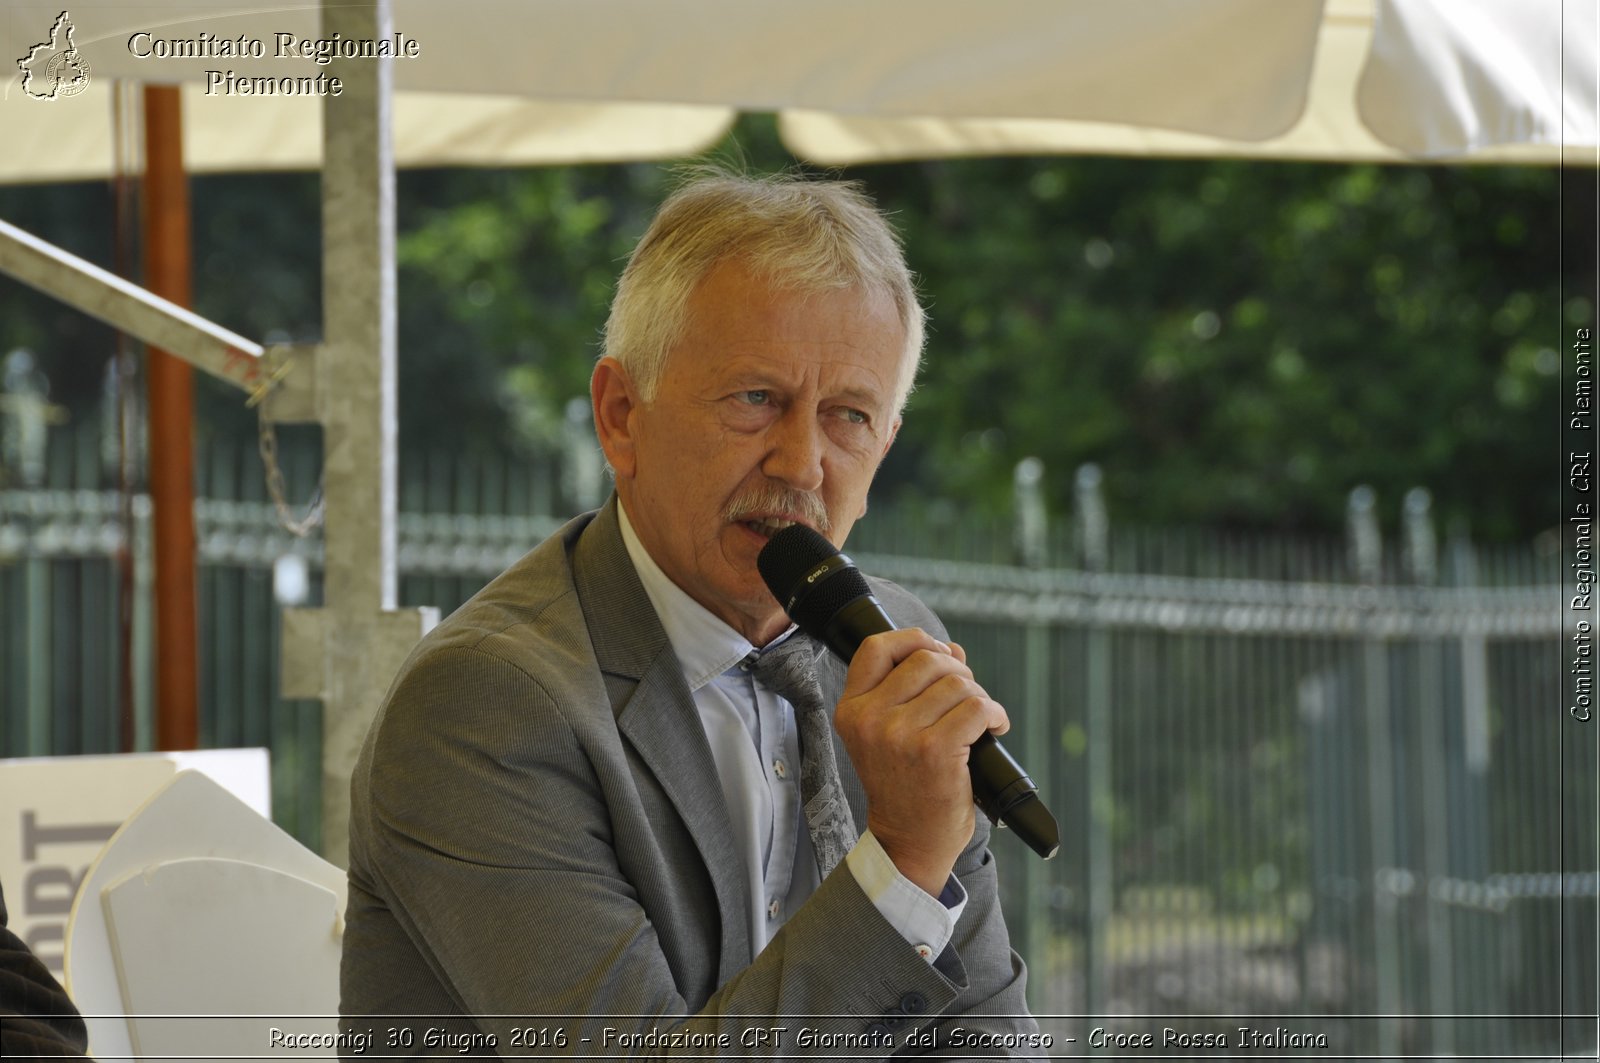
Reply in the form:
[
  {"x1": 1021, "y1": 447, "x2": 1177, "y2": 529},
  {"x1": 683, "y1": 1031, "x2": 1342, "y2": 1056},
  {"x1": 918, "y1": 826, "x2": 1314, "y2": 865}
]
[{"x1": 398, "y1": 166, "x2": 662, "y2": 450}]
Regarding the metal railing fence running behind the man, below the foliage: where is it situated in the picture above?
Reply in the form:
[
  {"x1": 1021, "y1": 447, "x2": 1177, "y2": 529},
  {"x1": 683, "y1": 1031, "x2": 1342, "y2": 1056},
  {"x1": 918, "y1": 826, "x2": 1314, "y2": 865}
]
[{"x1": 0, "y1": 416, "x2": 1600, "y2": 1055}]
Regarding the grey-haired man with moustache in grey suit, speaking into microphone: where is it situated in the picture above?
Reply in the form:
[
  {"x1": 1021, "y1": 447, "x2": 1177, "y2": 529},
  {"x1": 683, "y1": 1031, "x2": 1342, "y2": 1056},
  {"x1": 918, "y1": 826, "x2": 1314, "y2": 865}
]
[{"x1": 342, "y1": 176, "x2": 1048, "y2": 1058}]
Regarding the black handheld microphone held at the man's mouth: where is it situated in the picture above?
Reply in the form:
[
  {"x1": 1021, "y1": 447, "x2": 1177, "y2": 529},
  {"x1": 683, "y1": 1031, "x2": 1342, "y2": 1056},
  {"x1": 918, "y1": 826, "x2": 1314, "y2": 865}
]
[{"x1": 755, "y1": 523, "x2": 1061, "y2": 860}]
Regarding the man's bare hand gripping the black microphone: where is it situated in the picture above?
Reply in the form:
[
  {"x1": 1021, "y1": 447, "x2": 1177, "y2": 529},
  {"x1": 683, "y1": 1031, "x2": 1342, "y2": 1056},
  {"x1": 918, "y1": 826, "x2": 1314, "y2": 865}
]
[{"x1": 834, "y1": 628, "x2": 1011, "y2": 897}]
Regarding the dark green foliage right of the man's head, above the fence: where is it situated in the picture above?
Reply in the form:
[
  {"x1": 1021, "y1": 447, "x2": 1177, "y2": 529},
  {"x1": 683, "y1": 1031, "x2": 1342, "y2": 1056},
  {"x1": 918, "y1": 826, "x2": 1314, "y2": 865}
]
[{"x1": 864, "y1": 158, "x2": 1560, "y2": 538}]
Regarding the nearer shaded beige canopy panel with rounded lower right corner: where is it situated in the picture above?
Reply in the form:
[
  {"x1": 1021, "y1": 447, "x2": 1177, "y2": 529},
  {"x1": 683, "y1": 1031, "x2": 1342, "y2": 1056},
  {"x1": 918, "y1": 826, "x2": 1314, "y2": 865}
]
[{"x1": 0, "y1": 0, "x2": 1322, "y2": 125}]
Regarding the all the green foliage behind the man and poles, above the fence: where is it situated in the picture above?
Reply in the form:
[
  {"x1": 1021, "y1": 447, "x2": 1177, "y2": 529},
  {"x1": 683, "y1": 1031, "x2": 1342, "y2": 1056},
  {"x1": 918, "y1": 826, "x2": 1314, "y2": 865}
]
[{"x1": 0, "y1": 115, "x2": 1568, "y2": 540}]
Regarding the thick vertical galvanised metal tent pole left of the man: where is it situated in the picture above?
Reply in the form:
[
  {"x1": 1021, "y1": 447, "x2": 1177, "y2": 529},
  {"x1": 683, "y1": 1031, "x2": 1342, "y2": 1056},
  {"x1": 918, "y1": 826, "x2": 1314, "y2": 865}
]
[{"x1": 283, "y1": 0, "x2": 438, "y2": 864}]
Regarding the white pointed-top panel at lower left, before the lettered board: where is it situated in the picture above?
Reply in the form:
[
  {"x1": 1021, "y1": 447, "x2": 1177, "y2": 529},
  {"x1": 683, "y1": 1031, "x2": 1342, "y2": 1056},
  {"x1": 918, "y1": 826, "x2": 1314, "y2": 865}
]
[{"x1": 64, "y1": 772, "x2": 346, "y2": 1058}]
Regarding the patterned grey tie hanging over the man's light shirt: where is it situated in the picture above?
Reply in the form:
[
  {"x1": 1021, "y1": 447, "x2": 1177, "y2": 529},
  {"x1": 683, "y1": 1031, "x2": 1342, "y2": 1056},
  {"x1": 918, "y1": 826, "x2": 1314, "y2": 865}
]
[{"x1": 755, "y1": 632, "x2": 859, "y2": 879}]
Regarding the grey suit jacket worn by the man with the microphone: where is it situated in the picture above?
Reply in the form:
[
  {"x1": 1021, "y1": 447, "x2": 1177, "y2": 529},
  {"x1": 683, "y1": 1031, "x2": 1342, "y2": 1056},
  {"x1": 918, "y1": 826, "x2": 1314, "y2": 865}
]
[{"x1": 341, "y1": 498, "x2": 1037, "y2": 1058}]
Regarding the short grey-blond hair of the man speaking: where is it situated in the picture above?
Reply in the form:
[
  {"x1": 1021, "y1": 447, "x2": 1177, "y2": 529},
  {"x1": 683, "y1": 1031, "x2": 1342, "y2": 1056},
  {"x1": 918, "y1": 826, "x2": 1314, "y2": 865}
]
[{"x1": 603, "y1": 171, "x2": 926, "y2": 416}]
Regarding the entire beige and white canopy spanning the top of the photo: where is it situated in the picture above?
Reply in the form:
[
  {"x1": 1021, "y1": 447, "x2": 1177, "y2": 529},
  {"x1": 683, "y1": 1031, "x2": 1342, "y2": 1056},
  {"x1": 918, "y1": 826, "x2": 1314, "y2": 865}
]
[{"x1": 0, "y1": 0, "x2": 1600, "y2": 181}]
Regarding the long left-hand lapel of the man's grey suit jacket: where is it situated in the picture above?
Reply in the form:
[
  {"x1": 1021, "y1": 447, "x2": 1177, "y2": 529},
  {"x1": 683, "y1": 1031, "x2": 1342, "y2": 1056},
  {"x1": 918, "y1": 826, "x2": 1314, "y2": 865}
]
[{"x1": 573, "y1": 495, "x2": 752, "y2": 981}]
